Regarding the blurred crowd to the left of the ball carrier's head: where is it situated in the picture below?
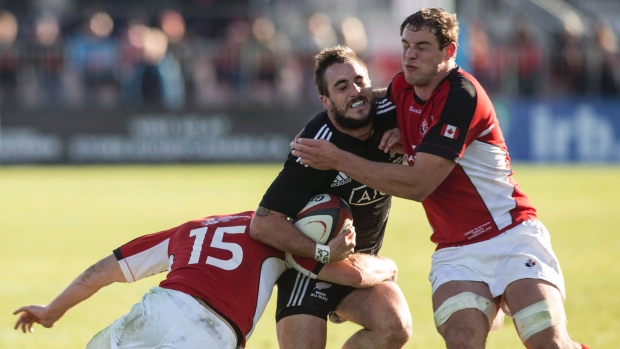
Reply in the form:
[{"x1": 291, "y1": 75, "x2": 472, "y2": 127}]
[{"x1": 0, "y1": 10, "x2": 324, "y2": 110}]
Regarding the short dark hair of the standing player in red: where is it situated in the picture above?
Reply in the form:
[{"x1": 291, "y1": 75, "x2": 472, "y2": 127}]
[{"x1": 400, "y1": 8, "x2": 459, "y2": 49}]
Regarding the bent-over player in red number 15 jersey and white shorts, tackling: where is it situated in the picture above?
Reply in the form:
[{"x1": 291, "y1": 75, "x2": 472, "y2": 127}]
[{"x1": 14, "y1": 211, "x2": 397, "y2": 349}]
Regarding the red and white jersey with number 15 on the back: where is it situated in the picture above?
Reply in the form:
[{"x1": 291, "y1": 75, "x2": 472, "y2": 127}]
[{"x1": 114, "y1": 211, "x2": 286, "y2": 346}]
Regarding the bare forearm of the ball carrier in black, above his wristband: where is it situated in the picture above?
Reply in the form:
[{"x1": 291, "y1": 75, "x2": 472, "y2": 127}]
[{"x1": 250, "y1": 207, "x2": 316, "y2": 258}]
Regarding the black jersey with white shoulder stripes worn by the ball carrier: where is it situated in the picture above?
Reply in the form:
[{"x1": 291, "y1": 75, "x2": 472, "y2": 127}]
[{"x1": 260, "y1": 101, "x2": 402, "y2": 254}]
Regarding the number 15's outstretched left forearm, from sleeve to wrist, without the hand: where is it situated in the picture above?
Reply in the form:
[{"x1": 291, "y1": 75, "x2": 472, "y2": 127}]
[{"x1": 46, "y1": 255, "x2": 125, "y2": 321}]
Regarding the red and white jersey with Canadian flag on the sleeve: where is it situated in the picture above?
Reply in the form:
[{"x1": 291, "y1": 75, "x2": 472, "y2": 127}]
[{"x1": 388, "y1": 67, "x2": 536, "y2": 249}]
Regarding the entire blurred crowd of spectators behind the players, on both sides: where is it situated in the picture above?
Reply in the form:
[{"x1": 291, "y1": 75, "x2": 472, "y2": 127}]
[{"x1": 0, "y1": 4, "x2": 620, "y2": 110}]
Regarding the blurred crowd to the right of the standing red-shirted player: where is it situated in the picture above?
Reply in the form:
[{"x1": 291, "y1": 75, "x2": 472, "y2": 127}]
[{"x1": 466, "y1": 13, "x2": 620, "y2": 98}]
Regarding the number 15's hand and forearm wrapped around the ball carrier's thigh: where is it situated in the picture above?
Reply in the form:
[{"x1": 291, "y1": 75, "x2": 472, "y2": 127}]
[{"x1": 317, "y1": 253, "x2": 398, "y2": 288}]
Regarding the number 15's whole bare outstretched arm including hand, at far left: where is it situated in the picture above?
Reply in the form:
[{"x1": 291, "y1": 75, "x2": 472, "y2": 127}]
[{"x1": 13, "y1": 254, "x2": 126, "y2": 333}]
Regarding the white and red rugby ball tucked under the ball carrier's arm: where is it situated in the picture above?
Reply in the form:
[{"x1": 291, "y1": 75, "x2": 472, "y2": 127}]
[{"x1": 286, "y1": 194, "x2": 353, "y2": 278}]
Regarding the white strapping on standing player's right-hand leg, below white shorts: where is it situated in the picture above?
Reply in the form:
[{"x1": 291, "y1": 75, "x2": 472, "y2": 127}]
[{"x1": 513, "y1": 301, "x2": 566, "y2": 343}]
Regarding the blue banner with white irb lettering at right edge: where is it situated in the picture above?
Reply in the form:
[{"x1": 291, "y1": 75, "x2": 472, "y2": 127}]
[{"x1": 495, "y1": 99, "x2": 620, "y2": 163}]
